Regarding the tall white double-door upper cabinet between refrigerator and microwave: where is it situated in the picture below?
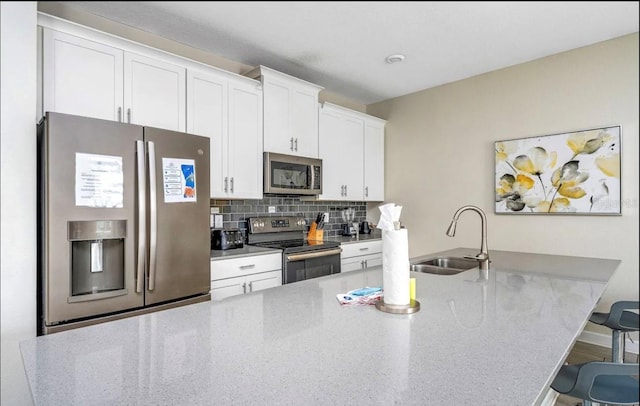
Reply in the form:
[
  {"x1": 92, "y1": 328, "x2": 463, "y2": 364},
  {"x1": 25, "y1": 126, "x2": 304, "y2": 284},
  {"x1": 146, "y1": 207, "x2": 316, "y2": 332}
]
[{"x1": 187, "y1": 69, "x2": 263, "y2": 199}]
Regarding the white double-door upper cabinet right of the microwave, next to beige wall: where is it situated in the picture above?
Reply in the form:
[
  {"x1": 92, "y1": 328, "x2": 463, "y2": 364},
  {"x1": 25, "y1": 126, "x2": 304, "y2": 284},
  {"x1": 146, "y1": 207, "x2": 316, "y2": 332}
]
[{"x1": 318, "y1": 102, "x2": 385, "y2": 201}]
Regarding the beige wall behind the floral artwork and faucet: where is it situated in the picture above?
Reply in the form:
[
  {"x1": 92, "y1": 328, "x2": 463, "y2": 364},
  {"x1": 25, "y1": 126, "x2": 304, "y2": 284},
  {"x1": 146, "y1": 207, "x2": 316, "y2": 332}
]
[{"x1": 367, "y1": 33, "x2": 639, "y2": 334}]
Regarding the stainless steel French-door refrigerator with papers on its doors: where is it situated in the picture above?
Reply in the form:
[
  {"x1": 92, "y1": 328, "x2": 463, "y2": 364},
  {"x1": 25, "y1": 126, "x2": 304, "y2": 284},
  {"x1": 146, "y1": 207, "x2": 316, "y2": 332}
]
[{"x1": 38, "y1": 112, "x2": 211, "y2": 335}]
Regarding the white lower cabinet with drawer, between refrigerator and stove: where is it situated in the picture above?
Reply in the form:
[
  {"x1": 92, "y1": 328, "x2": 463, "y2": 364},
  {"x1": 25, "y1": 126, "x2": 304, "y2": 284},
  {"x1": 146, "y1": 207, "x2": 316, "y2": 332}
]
[{"x1": 211, "y1": 252, "x2": 282, "y2": 300}]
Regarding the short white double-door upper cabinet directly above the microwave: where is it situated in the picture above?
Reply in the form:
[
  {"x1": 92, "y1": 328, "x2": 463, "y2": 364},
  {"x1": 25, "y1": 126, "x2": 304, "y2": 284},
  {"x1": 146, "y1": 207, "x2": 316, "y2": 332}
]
[{"x1": 245, "y1": 66, "x2": 323, "y2": 158}]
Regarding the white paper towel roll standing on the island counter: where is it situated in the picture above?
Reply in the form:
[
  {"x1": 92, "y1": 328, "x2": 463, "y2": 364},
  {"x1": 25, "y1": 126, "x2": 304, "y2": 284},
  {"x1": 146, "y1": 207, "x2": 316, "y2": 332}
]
[{"x1": 382, "y1": 228, "x2": 410, "y2": 306}]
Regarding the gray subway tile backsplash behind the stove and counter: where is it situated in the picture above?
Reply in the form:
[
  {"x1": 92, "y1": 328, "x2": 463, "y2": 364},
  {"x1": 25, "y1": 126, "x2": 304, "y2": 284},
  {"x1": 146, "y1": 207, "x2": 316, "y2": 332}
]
[{"x1": 210, "y1": 195, "x2": 370, "y2": 237}]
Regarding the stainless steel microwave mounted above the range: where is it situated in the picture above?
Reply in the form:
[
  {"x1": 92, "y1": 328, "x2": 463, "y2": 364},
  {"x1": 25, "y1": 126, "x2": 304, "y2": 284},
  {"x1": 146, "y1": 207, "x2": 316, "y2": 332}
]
[{"x1": 264, "y1": 152, "x2": 322, "y2": 195}]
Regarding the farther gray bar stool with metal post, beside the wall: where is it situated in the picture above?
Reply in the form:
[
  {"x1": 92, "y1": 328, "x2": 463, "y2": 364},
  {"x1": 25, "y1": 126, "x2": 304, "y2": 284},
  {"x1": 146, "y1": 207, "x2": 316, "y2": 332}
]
[{"x1": 589, "y1": 300, "x2": 640, "y2": 363}]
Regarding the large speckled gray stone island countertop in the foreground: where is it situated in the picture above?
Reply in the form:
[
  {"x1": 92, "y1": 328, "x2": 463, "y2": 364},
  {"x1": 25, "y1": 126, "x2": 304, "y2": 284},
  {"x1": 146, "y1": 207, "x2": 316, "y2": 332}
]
[{"x1": 20, "y1": 249, "x2": 620, "y2": 406}]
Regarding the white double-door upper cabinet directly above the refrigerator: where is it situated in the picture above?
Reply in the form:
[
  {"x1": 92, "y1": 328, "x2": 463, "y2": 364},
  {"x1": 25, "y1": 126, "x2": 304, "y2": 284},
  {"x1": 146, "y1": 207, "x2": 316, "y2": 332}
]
[{"x1": 42, "y1": 27, "x2": 186, "y2": 131}]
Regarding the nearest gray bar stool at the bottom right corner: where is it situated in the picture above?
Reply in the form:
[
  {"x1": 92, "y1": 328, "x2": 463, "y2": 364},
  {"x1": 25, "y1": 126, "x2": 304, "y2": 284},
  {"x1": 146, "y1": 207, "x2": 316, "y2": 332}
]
[{"x1": 551, "y1": 362, "x2": 640, "y2": 406}]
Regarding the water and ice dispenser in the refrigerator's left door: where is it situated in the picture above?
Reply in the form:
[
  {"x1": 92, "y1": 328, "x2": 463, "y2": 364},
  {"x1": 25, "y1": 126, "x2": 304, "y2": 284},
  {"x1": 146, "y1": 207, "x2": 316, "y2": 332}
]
[{"x1": 68, "y1": 220, "x2": 127, "y2": 300}]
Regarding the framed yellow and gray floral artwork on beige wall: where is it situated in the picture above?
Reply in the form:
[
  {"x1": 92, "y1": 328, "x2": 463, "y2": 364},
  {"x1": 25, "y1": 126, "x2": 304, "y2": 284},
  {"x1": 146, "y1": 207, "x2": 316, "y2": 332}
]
[{"x1": 494, "y1": 126, "x2": 621, "y2": 215}]
